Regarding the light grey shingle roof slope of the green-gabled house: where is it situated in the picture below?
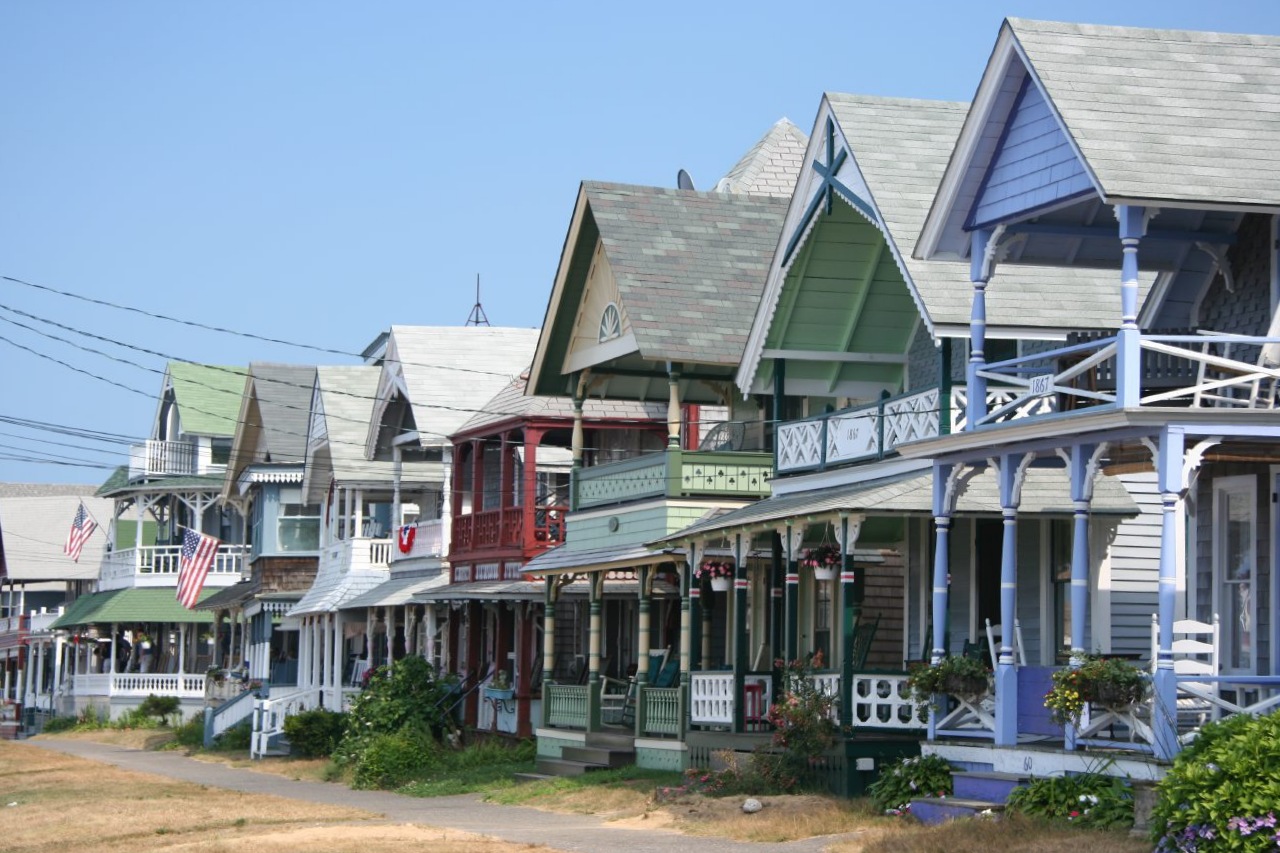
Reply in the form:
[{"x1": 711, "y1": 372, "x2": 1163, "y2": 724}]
[{"x1": 827, "y1": 92, "x2": 1155, "y2": 329}]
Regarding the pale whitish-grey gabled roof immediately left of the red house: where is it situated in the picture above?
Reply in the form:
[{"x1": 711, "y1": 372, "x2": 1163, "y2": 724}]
[{"x1": 364, "y1": 325, "x2": 538, "y2": 455}]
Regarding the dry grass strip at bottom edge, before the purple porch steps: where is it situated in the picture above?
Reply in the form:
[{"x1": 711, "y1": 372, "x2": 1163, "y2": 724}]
[{"x1": 827, "y1": 816, "x2": 1151, "y2": 853}]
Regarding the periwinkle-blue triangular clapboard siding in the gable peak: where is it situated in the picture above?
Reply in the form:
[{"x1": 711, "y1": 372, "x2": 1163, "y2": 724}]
[{"x1": 973, "y1": 81, "x2": 1093, "y2": 225}]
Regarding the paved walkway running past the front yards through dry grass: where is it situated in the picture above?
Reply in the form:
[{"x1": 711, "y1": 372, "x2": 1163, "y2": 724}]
[{"x1": 23, "y1": 738, "x2": 836, "y2": 853}]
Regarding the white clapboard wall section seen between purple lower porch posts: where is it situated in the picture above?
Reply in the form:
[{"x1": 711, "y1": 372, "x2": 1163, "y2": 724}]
[{"x1": 1111, "y1": 473, "x2": 1161, "y2": 656}]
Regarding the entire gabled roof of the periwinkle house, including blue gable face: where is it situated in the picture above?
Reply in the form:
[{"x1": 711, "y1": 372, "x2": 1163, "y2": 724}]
[{"x1": 915, "y1": 18, "x2": 1280, "y2": 265}]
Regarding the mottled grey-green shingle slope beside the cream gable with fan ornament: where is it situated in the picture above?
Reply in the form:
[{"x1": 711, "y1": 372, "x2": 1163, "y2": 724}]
[{"x1": 582, "y1": 182, "x2": 786, "y2": 366}]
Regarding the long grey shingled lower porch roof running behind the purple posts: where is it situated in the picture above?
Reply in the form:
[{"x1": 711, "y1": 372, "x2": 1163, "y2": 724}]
[{"x1": 654, "y1": 466, "x2": 1138, "y2": 546}]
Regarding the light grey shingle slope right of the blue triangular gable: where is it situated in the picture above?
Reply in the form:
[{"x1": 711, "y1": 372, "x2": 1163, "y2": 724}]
[{"x1": 1007, "y1": 18, "x2": 1280, "y2": 205}]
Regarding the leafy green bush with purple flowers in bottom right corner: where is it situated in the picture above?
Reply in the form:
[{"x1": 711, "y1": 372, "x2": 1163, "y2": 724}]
[{"x1": 1152, "y1": 711, "x2": 1280, "y2": 850}]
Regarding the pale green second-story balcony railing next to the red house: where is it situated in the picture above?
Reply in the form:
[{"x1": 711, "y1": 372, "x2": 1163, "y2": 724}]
[{"x1": 573, "y1": 450, "x2": 773, "y2": 510}]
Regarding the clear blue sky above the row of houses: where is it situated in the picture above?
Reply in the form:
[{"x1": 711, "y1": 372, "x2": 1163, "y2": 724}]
[{"x1": 0, "y1": 0, "x2": 1280, "y2": 483}]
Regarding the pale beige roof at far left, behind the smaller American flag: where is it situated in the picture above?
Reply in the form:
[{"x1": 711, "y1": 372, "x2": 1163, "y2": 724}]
[{"x1": 0, "y1": 484, "x2": 114, "y2": 581}]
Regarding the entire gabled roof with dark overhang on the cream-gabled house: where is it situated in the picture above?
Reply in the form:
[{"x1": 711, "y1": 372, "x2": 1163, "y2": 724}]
[{"x1": 530, "y1": 182, "x2": 786, "y2": 396}]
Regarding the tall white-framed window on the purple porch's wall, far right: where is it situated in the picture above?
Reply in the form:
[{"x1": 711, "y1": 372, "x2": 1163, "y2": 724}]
[{"x1": 1213, "y1": 476, "x2": 1258, "y2": 672}]
